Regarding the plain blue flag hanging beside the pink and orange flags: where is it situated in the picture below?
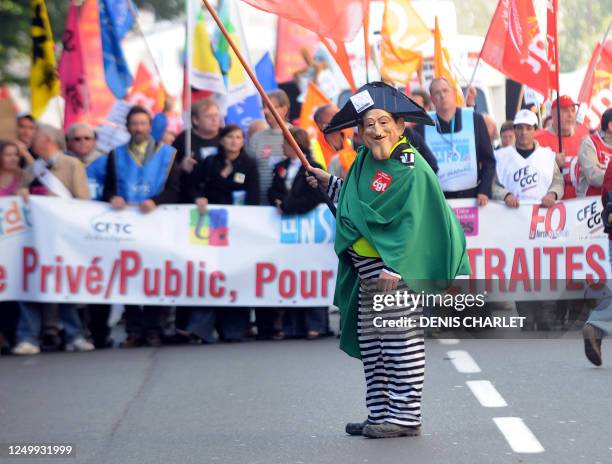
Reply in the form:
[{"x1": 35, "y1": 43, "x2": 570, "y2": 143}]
[{"x1": 98, "y1": 0, "x2": 134, "y2": 99}]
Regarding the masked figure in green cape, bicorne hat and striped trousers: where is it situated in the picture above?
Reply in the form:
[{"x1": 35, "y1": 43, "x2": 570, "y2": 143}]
[{"x1": 309, "y1": 82, "x2": 470, "y2": 438}]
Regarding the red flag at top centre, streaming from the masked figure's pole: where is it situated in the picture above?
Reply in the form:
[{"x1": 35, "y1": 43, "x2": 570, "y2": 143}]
[{"x1": 243, "y1": 0, "x2": 369, "y2": 42}]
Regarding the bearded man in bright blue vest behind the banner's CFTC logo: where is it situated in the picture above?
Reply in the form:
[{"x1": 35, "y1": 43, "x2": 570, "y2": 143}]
[{"x1": 102, "y1": 106, "x2": 180, "y2": 348}]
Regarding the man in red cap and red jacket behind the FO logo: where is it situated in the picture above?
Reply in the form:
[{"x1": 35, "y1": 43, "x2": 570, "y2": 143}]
[{"x1": 536, "y1": 95, "x2": 589, "y2": 200}]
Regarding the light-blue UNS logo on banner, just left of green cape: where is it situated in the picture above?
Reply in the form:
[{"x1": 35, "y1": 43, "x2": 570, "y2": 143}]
[{"x1": 280, "y1": 207, "x2": 336, "y2": 245}]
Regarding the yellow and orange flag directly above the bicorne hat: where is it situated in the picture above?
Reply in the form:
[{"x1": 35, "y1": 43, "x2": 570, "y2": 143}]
[{"x1": 381, "y1": 0, "x2": 431, "y2": 84}]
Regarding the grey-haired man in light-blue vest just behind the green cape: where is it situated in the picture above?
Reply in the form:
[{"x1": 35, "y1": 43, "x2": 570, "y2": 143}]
[{"x1": 416, "y1": 77, "x2": 495, "y2": 206}]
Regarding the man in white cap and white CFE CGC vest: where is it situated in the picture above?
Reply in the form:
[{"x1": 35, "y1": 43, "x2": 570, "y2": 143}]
[{"x1": 495, "y1": 110, "x2": 563, "y2": 208}]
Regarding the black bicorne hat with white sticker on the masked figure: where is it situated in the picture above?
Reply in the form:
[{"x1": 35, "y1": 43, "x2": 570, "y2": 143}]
[{"x1": 323, "y1": 82, "x2": 435, "y2": 134}]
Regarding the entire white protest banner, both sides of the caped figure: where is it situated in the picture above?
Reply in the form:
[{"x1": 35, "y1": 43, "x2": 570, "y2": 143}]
[{"x1": 0, "y1": 196, "x2": 611, "y2": 307}]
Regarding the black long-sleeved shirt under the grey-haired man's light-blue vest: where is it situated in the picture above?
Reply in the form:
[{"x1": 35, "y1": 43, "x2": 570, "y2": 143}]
[{"x1": 415, "y1": 108, "x2": 495, "y2": 198}]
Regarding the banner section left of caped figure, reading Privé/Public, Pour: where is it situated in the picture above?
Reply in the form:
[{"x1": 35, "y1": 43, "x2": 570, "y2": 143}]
[{"x1": 0, "y1": 197, "x2": 337, "y2": 306}]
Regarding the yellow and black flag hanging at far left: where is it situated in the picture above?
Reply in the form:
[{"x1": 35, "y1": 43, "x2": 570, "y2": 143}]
[{"x1": 30, "y1": 0, "x2": 60, "y2": 118}]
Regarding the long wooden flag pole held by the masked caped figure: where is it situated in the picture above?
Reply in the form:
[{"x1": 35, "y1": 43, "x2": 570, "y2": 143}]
[{"x1": 201, "y1": 0, "x2": 336, "y2": 216}]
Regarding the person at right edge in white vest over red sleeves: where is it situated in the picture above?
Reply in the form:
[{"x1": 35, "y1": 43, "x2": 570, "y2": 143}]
[{"x1": 576, "y1": 108, "x2": 612, "y2": 197}]
